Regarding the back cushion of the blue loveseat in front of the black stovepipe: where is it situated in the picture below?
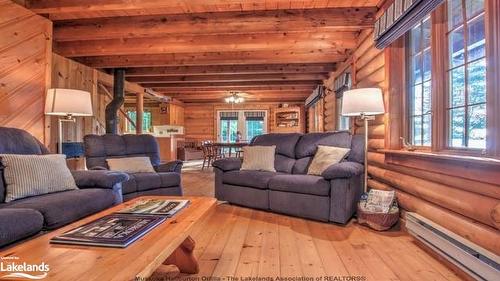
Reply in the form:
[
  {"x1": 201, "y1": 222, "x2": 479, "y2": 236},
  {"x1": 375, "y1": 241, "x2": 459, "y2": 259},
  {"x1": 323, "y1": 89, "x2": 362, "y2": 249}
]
[{"x1": 83, "y1": 134, "x2": 160, "y2": 169}]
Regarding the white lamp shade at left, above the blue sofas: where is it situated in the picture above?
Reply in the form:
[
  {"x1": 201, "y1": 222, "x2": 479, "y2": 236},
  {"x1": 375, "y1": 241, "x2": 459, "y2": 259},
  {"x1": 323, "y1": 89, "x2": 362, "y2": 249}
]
[{"x1": 45, "y1": 89, "x2": 93, "y2": 116}]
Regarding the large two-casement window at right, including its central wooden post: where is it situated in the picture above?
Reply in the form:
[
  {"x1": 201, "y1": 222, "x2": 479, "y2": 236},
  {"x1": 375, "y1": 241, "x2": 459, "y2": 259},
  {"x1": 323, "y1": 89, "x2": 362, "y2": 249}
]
[{"x1": 405, "y1": 0, "x2": 488, "y2": 154}]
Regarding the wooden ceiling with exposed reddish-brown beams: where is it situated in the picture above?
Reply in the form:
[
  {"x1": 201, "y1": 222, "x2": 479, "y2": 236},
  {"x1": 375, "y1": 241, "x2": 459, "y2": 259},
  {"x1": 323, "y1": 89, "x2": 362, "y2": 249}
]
[{"x1": 17, "y1": 0, "x2": 379, "y2": 102}]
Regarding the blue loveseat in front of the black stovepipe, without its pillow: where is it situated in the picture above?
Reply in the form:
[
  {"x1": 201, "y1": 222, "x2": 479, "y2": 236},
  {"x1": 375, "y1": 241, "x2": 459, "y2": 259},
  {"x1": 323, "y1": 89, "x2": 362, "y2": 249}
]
[{"x1": 83, "y1": 134, "x2": 183, "y2": 201}]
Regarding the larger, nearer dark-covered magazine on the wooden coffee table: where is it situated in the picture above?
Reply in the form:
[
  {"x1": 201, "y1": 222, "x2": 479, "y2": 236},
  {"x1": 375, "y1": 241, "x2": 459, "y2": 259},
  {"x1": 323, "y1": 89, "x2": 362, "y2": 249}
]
[{"x1": 50, "y1": 213, "x2": 165, "y2": 248}]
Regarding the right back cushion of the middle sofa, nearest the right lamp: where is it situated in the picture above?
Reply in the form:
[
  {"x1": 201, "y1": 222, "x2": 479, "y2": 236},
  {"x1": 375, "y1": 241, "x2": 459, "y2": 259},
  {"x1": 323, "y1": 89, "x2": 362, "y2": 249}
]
[{"x1": 292, "y1": 131, "x2": 352, "y2": 174}]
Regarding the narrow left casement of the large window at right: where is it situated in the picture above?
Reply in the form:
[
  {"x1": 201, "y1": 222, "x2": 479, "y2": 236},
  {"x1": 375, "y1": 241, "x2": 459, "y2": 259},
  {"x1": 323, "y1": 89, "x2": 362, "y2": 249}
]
[{"x1": 406, "y1": 16, "x2": 432, "y2": 146}]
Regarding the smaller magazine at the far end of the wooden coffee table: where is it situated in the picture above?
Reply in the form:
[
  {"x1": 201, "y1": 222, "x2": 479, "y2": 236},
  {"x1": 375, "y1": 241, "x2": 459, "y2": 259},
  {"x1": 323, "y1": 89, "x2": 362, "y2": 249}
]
[{"x1": 118, "y1": 199, "x2": 189, "y2": 218}]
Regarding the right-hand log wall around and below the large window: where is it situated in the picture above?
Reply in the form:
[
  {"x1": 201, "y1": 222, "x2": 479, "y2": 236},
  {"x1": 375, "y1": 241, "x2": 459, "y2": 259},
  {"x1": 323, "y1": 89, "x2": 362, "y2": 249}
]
[{"x1": 325, "y1": 28, "x2": 500, "y2": 255}]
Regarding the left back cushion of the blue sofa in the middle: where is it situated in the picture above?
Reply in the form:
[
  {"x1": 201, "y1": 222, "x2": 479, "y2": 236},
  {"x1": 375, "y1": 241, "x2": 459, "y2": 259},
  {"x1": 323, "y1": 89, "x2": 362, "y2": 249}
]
[{"x1": 250, "y1": 133, "x2": 302, "y2": 174}]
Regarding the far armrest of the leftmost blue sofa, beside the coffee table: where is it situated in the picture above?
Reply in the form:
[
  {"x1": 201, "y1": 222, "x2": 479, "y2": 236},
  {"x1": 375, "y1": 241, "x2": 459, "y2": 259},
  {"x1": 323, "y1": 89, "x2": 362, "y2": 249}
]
[{"x1": 71, "y1": 170, "x2": 129, "y2": 189}]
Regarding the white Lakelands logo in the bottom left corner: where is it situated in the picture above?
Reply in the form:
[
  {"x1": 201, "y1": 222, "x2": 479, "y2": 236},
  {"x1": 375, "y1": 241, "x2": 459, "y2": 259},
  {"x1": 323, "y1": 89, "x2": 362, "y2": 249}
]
[{"x1": 0, "y1": 256, "x2": 50, "y2": 280}]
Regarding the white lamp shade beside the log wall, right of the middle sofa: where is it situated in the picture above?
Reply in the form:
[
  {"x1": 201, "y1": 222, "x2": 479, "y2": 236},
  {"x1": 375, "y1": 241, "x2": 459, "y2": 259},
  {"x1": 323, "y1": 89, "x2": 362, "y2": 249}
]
[{"x1": 342, "y1": 88, "x2": 385, "y2": 116}]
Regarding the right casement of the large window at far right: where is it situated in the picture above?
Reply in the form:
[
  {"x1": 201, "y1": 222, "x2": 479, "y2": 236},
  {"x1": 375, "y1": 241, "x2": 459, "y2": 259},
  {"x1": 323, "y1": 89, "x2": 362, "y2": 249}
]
[{"x1": 447, "y1": 0, "x2": 486, "y2": 149}]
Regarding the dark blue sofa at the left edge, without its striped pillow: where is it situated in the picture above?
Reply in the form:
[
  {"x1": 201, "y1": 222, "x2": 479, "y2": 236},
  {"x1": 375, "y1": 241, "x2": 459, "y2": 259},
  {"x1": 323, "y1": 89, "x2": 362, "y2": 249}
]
[{"x1": 0, "y1": 127, "x2": 128, "y2": 247}]
